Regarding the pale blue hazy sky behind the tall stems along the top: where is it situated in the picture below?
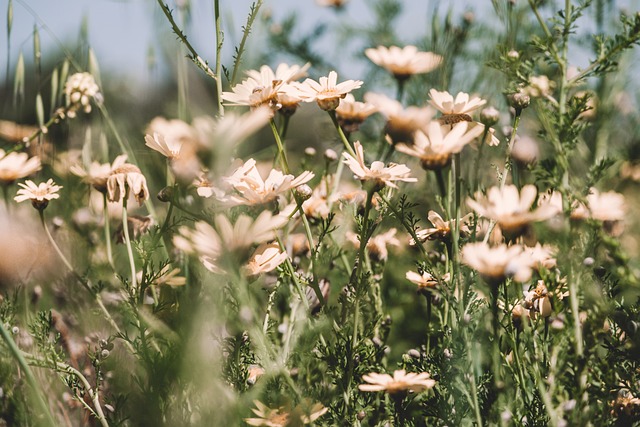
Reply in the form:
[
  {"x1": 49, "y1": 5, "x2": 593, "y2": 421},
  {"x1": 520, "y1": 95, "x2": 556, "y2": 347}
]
[{"x1": 0, "y1": 0, "x2": 448, "y2": 80}]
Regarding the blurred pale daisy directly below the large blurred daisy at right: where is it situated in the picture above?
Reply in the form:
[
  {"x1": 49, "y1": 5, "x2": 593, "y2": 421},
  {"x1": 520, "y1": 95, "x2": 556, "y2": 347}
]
[{"x1": 462, "y1": 242, "x2": 531, "y2": 285}]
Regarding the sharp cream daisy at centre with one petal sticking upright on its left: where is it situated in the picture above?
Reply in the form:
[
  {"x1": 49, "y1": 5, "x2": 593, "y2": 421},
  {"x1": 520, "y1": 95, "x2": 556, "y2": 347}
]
[{"x1": 342, "y1": 141, "x2": 418, "y2": 191}]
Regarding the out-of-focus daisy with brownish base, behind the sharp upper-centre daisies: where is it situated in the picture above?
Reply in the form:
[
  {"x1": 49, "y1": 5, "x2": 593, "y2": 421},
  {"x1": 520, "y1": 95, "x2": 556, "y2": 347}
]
[{"x1": 364, "y1": 92, "x2": 435, "y2": 144}]
